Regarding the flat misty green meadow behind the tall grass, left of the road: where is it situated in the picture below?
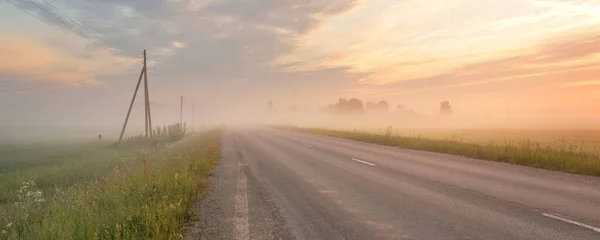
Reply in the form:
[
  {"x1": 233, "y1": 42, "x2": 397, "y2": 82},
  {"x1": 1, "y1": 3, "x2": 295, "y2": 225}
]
[{"x1": 0, "y1": 141, "x2": 145, "y2": 205}]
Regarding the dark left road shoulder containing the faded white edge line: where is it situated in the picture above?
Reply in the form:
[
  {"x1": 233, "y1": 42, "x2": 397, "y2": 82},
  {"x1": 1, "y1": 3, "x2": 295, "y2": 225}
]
[{"x1": 184, "y1": 134, "x2": 294, "y2": 239}]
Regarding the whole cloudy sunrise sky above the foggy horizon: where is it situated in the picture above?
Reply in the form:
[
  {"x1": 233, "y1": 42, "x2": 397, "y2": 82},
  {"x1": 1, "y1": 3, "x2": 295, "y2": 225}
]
[{"x1": 0, "y1": 0, "x2": 600, "y2": 131}]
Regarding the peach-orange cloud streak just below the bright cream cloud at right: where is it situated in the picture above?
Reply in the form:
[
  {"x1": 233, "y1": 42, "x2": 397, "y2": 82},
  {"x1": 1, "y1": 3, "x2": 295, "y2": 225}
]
[{"x1": 332, "y1": 31, "x2": 600, "y2": 103}]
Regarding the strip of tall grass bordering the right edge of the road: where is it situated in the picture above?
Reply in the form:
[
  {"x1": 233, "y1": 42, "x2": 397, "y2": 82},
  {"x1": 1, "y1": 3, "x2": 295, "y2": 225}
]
[{"x1": 286, "y1": 127, "x2": 600, "y2": 176}]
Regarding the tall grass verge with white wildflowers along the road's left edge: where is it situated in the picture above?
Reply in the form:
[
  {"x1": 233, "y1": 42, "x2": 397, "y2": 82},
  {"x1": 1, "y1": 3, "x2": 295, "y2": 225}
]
[{"x1": 0, "y1": 130, "x2": 220, "y2": 239}]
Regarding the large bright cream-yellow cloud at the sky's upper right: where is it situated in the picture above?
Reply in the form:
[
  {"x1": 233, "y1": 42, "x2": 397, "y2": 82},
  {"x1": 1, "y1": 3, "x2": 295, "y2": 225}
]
[{"x1": 279, "y1": 0, "x2": 600, "y2": 85}]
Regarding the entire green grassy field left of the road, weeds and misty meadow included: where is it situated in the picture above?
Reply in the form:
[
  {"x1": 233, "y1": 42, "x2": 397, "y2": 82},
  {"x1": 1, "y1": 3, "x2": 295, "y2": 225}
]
[{"x1": 0, "y1": 130, "x2": 220, "y2": 239}]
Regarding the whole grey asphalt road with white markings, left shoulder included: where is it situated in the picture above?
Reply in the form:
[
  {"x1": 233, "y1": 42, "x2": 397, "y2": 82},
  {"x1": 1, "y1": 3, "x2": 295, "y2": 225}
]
[{"x1": 188, "y1": 128, "x2": 600, "y2": 240}]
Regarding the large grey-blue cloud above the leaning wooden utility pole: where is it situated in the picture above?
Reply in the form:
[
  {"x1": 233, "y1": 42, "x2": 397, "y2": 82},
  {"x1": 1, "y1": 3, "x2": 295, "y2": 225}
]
[{"x1": 2, "y1": 0, "x2": 363, "y2": 95}]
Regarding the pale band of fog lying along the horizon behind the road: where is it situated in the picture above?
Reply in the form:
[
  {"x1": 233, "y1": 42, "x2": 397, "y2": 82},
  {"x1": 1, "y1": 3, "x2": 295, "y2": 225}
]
[{"x1": 0, "y1": 94, "x2": 598, "y2": 143}]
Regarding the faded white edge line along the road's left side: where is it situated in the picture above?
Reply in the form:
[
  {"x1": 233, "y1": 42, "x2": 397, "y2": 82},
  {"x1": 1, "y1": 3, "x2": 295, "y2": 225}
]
[{"x1": 233, "y1": 165, "x2": 250, "y2": 240}]
